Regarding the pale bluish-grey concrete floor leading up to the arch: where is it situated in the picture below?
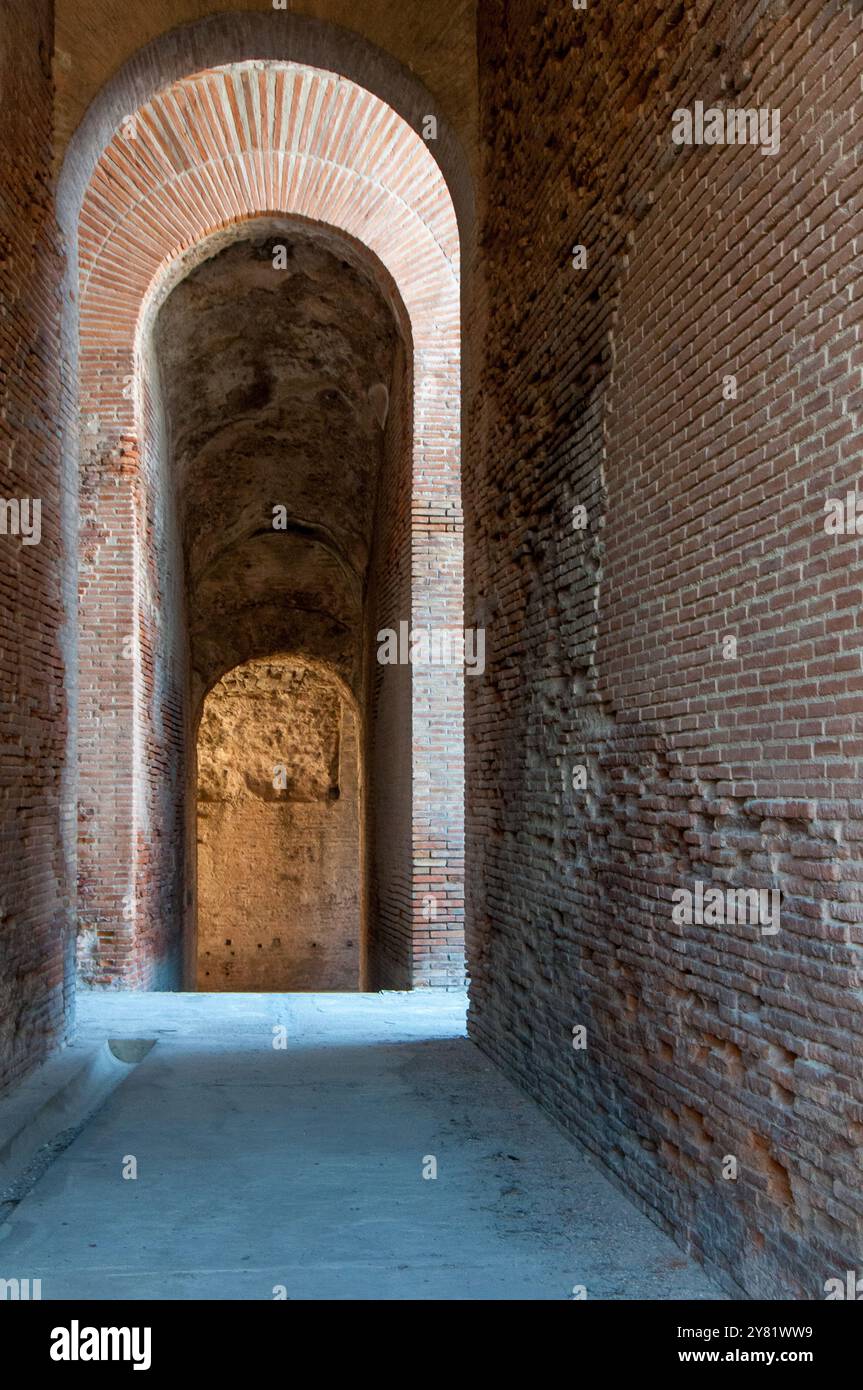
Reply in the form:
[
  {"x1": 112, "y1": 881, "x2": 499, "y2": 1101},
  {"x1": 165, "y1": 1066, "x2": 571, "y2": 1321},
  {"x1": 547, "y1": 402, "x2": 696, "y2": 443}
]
[{"x1": 0, "y1": 992, "x2": 724, "y2": 1300}]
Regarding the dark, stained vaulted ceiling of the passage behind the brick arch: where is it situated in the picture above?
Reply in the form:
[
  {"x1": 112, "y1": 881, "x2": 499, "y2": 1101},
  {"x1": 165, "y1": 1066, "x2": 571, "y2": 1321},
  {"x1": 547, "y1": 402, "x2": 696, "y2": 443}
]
[{"x1": 156, "y1": 227, "x2": 397, "y2": 699}]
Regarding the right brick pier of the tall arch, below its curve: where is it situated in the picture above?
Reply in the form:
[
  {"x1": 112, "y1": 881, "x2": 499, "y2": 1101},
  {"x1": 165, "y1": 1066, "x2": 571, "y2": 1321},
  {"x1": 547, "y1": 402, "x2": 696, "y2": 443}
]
[{"x1": 365, "y1": 325, "x2": 466, "y2": 990}]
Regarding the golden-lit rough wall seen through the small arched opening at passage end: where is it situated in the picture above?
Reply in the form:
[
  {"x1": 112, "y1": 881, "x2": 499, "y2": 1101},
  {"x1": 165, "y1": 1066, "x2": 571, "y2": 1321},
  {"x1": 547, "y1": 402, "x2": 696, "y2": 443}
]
[{"x1": 197, "y1": 657, "x2": 361, "y2": 992}]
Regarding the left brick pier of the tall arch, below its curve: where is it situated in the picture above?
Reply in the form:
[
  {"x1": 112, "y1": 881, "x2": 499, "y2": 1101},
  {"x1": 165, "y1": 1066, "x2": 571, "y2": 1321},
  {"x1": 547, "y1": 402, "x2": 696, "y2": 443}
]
[{"x1": 78, "y1": 250, "x2": 190, "y2": 988}]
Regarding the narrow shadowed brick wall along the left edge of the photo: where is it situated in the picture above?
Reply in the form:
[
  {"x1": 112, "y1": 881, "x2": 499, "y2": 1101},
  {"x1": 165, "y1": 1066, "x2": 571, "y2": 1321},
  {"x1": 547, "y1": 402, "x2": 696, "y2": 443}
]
[{"x1": 0, "y1": 0, "x2": 75, "y2": 1088}]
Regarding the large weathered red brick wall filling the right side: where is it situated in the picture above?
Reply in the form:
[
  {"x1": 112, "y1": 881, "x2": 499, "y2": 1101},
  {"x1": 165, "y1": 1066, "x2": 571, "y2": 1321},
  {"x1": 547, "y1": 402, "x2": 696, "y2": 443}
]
[{"x1": 466, "y1": 0, "x2": 863, "y2": 1298}]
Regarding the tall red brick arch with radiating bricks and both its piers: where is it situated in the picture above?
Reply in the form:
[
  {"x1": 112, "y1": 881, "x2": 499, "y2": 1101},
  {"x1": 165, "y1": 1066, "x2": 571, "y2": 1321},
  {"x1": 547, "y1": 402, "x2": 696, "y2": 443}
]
[{"x1": 67, "y1": 51, "x2": 463, "y2": 987}]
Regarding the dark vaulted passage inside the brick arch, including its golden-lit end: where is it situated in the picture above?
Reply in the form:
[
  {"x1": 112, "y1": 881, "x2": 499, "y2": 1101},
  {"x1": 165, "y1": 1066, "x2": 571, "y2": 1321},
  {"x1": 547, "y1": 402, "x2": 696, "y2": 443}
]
[{"x1": 150, "y1": 218, "x2": 410, "y2": 990}]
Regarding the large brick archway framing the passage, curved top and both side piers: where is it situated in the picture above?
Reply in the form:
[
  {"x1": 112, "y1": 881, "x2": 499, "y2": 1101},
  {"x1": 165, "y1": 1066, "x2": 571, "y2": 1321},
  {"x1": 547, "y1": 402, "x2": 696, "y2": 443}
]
[{"x1": 62, "y1": 29, "x2": 464, "y2": 988}]
